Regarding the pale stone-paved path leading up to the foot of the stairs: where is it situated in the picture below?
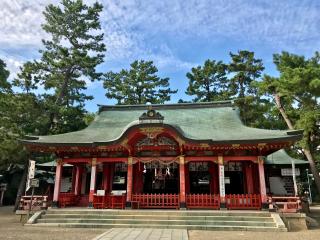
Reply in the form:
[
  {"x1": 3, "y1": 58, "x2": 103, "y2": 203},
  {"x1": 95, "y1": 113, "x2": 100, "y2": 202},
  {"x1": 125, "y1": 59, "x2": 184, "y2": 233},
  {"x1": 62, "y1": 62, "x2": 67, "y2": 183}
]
[{"x1": 93, "y1": 228, "x2": 188, "y2": 240}]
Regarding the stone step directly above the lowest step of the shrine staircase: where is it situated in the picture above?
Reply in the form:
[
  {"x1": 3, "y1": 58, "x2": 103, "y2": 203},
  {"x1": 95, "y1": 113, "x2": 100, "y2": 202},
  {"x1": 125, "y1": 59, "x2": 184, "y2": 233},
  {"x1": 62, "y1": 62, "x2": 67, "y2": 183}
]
[{"x1": 38, "y1": 218, "x2": 276, "y2": 227}]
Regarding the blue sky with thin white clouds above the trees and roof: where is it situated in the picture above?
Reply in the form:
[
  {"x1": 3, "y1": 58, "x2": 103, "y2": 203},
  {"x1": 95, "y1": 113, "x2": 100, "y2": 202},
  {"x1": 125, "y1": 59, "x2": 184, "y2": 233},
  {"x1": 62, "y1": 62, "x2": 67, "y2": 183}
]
[{"x1": 0, "y1": 0, "x2": 320, "y2": 111}]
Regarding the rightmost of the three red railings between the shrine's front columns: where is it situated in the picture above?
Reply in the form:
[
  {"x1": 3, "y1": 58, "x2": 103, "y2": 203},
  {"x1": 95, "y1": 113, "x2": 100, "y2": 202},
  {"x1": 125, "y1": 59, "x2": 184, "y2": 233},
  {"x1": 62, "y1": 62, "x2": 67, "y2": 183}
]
[{"x1": 226, "y1": 194, "x2": 261, "y2": 209}]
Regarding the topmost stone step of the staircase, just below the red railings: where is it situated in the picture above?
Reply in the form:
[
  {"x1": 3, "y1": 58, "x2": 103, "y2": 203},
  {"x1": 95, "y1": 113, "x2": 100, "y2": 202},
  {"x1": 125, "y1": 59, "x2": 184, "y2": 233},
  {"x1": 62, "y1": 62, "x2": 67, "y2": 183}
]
[{"x1": 47, "y1": 209, "x2": 270, "y2": 217}]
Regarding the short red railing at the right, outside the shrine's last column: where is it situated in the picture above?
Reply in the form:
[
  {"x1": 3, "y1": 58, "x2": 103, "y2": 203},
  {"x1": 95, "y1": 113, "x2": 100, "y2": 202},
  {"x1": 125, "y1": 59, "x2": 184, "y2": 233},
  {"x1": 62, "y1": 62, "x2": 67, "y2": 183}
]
[{"x1": 268, "y1": 197, "x2": 302, "y2": 213}]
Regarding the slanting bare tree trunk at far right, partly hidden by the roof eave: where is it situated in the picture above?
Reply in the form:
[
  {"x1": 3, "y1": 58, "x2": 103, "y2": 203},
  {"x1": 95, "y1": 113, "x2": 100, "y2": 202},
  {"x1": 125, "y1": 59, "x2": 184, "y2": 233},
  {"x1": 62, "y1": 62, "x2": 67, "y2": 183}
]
[{"x1": 273, "y1": 93, "x2": 320, "y2": 193}]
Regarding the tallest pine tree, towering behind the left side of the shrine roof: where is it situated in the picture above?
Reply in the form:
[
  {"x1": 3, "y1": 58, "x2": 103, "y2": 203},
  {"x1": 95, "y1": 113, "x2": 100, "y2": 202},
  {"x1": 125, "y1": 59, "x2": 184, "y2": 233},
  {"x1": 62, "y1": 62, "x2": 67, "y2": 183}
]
[{"x1": 14, "y1": 0, "x2": 105, "y2": 134}]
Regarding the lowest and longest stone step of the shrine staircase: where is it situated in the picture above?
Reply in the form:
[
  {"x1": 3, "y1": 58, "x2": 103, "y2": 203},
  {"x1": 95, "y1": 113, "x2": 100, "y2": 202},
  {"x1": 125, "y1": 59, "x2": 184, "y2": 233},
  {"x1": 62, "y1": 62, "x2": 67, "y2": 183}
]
[{"x1": 32, "y1": 223, "x2": 287, "y2": 232}]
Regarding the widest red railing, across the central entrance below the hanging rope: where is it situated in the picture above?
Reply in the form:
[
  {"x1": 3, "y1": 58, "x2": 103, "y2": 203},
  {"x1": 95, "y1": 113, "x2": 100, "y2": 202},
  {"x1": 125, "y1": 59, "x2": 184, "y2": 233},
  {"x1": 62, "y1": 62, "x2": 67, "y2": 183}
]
[{"x1": 132, "y1": 194, "x2": 179, "y2": 209}]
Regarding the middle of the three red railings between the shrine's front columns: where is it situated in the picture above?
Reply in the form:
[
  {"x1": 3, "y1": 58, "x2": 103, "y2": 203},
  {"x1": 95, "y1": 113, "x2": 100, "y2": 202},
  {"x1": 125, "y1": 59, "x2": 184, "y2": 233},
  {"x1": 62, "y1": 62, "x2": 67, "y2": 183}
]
[{"x1": 186, "y1": 194, "x2": 220, "y2": 209}]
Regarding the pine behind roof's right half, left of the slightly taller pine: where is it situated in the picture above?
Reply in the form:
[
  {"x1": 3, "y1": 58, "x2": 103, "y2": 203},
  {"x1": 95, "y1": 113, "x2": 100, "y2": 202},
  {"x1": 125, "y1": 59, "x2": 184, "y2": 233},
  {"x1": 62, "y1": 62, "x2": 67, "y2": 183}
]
[{"x1": 186, "y1": 59, "x2": 231, "y2": 102}]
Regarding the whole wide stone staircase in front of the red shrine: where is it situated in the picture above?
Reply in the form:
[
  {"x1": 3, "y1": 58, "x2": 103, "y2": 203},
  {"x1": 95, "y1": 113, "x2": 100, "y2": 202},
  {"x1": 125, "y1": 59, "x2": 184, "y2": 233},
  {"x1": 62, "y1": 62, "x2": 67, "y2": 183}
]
[{"x1": 32, "y1": 208, "x2": 287, "y2": 231}]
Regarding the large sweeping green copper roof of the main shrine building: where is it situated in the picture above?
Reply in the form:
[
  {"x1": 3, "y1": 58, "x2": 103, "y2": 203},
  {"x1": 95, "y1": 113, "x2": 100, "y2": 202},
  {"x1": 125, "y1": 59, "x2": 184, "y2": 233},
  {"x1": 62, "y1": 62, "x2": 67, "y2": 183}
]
[{"x1": 22, "y1": 101, "x2": 301, "y2": 145}]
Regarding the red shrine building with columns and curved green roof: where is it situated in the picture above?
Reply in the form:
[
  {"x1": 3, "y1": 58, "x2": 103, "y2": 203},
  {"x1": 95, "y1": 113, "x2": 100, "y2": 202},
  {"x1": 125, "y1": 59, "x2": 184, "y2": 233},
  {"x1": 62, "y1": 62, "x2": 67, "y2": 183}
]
[{"x1": 22, "y1": 101, "x2": 302, "y2": 209}]
